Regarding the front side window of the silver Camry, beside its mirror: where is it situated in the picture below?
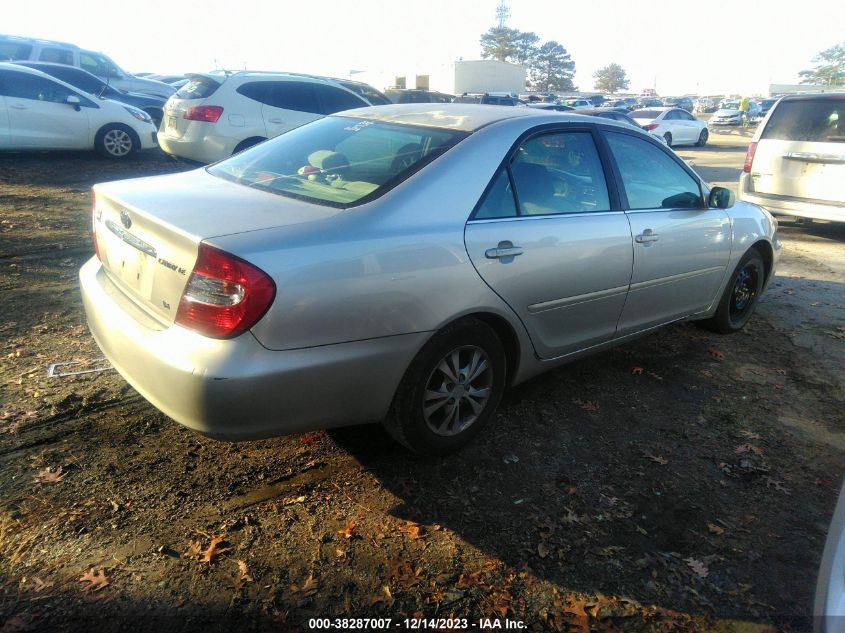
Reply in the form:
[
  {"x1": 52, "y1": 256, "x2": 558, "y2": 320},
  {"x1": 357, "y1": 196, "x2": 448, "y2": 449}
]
[{"x1": 605, "y1": 132, "x2": 704, "y2": 209}]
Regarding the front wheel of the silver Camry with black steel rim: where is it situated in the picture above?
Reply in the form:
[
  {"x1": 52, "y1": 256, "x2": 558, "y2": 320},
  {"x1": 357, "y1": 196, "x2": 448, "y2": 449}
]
[{"x1": 699, "y1": 248, "x2": 766, "y2": 334}]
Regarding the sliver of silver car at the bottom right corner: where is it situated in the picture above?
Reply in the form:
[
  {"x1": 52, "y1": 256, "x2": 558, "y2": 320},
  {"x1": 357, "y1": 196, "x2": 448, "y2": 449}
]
[{"x1": 813, "y1": 476, "x2": 845, "y2": 633}]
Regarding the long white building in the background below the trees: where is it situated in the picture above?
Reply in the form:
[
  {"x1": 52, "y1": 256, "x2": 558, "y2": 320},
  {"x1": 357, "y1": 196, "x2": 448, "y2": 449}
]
[{"x1": 354, "y1": 59, "x2": 526, "y2": 95}]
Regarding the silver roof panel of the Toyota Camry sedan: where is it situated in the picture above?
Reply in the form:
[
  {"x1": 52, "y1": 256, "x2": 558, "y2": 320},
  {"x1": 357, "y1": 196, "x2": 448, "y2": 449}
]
[{"x1": 334, "y1": 103, "x2": 620, "y2": 132}]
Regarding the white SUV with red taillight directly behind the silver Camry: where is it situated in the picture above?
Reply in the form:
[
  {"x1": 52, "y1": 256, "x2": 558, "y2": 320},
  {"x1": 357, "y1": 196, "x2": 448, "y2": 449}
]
[{"x1": 158, "y1": 71, "x2": 390, "y2": 163}]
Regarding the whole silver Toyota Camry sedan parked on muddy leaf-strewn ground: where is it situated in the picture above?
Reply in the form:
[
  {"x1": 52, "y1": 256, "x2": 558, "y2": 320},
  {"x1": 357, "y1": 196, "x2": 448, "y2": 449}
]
[{"x1": 80, "y1": 104, "x2": 779, "y2": 454}]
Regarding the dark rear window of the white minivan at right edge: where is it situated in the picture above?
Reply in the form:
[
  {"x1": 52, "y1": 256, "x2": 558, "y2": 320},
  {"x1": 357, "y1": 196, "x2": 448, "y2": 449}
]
[{"x1": 760, "y1": 97, "x2": 845, "y2": 143}]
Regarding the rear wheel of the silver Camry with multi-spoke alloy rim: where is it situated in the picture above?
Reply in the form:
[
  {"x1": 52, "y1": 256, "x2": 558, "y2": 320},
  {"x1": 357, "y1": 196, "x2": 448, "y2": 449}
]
[{"x1": 384, "y1": 318, "x2": 507, "y2": 455}]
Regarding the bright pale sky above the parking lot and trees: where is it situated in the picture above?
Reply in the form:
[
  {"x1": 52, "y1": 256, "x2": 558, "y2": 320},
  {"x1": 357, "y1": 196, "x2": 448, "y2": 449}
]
[{"x1": 0, "y1": 0, "x2": 845, "y2": 96}]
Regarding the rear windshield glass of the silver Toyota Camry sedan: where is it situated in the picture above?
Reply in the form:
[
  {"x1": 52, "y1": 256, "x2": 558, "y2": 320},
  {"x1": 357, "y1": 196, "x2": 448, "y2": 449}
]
[{"x1": 208, "y1": 116, "x2": 467, "y2": 208}]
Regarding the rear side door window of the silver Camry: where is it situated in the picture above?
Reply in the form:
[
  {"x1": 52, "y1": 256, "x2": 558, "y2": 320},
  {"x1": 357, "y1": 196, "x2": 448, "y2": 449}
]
[{"x1": 510, "y1": 132, "x2": 610, "y2": 215}]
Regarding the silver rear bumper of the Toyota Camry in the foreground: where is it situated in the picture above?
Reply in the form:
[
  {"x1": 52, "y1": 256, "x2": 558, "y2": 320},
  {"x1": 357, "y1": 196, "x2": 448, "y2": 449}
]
[{"x1": 79, "y1": 257, "x2": 428, "y2": 440}]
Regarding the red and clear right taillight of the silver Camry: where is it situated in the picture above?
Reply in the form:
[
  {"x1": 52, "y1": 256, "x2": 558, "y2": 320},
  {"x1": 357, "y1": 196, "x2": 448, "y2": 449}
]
[{"x1": 176, "y1": 244, "x2": 276, "y2": 338}]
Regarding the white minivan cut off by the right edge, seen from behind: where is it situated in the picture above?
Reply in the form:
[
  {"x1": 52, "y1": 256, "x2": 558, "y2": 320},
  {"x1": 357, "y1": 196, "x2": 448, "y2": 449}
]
[{"x1": 739, "y1": 92, "x2": 845, "y2": 222}]
